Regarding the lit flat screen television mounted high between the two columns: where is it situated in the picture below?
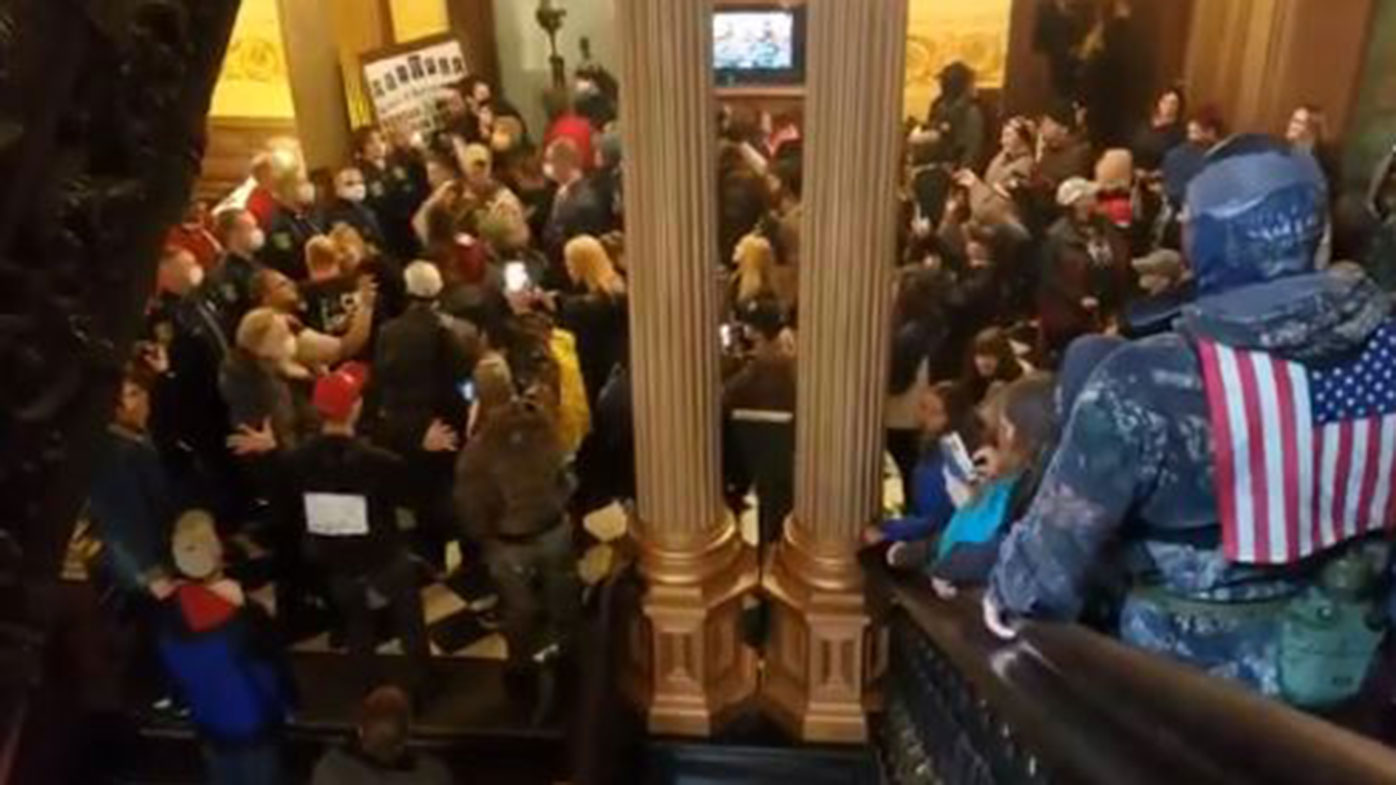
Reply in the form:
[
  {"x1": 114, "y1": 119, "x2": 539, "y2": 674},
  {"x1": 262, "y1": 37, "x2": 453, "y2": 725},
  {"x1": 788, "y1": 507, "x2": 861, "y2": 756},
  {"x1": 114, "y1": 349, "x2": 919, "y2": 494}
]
[{"x1": 712, "y1": 6, "x2": 804, "y2": 87}]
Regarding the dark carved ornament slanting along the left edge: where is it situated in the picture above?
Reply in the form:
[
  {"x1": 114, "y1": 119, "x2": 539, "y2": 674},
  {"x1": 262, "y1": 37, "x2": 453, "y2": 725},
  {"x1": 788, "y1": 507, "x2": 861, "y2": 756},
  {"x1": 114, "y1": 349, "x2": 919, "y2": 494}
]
[{"x1": 0, "y1": 0, "x2": 237, "y2": 759}]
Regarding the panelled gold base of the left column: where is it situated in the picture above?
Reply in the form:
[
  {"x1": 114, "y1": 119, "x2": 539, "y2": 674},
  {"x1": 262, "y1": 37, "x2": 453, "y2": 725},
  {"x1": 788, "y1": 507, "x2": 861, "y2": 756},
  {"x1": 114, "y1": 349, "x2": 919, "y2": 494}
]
[{"x1": 625, "y1": 524, "x2": 759, "y2": 736}]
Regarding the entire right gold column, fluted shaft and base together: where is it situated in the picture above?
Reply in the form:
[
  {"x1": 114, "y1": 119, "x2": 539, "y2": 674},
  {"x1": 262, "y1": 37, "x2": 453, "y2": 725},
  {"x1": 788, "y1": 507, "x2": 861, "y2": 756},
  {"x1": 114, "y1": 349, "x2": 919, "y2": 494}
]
[{"x1": 762, "y1": 0, "x2": 907, "y2": 742}]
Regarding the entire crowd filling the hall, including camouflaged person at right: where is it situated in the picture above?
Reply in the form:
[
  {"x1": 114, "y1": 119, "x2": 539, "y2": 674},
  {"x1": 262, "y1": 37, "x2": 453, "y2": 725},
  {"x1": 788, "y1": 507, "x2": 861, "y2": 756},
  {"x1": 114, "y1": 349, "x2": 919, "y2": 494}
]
[{"x1": 79, "y1": 6, "x2": 1396, "y2": 784}]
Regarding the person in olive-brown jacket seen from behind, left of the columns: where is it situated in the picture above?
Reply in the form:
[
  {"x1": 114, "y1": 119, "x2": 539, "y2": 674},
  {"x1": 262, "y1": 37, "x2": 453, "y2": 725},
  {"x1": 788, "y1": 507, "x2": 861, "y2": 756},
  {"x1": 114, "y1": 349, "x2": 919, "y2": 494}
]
[{"x1": 455, "y1": 356, "x2": 581, "y2": 677}]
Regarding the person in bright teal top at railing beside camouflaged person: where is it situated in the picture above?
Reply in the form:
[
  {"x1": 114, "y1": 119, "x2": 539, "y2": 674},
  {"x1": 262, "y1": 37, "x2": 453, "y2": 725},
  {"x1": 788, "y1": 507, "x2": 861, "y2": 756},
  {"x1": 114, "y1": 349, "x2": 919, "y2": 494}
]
[{"x1": 926, "y1": 374, "x2": 1058, "y2": 598}]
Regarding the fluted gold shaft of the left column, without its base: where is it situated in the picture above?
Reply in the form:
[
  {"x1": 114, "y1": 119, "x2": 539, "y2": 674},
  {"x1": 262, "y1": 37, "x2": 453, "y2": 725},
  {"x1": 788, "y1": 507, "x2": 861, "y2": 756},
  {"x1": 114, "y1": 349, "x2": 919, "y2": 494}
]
[{"x1": 617, "y1": 0, "x2": 726, "y2": 550}]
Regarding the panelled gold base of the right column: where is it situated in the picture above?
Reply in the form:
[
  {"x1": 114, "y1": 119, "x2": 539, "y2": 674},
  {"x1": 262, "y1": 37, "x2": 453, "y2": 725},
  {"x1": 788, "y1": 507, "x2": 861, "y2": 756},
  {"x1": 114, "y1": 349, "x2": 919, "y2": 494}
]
[{"x1": 761, "y1": 525, "x2": 875, "y2": 743}]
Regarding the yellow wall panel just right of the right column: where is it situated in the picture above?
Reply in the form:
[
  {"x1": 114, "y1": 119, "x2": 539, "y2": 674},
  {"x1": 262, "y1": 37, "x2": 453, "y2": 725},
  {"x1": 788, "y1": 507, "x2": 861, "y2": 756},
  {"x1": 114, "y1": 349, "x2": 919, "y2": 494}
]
[{"x1": 903, "y1": 0, "x2": 1012, "y2": 117}]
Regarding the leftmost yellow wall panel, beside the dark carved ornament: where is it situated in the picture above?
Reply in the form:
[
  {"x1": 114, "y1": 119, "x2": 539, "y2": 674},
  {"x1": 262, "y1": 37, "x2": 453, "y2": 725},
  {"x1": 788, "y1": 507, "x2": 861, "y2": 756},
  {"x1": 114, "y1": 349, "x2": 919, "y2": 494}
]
[{"x1": 209, "y1": 0, "x2": 296, "y2": 120}]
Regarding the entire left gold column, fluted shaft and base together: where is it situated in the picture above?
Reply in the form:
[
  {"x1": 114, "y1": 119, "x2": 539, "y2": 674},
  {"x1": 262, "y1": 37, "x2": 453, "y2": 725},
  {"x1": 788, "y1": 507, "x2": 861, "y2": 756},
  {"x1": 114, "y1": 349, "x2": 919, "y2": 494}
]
[{"x1": 618, "y1": 0, "x2": 755, "y2": 735}]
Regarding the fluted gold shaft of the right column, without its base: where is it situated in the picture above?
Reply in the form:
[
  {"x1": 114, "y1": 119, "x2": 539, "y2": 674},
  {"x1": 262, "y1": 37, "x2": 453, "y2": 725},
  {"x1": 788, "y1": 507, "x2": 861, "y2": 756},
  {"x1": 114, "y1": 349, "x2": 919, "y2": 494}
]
[{"x1": 790, "y1": 0, "x2": 906, "y2": 556}]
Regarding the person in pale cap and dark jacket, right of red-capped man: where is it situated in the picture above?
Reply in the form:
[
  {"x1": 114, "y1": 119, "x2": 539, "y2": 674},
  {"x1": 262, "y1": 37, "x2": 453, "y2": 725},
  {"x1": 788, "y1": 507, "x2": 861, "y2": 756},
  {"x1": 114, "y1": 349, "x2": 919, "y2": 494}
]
[{"x1": 373, "y1": 261, "x2": 475, "y2": 568}]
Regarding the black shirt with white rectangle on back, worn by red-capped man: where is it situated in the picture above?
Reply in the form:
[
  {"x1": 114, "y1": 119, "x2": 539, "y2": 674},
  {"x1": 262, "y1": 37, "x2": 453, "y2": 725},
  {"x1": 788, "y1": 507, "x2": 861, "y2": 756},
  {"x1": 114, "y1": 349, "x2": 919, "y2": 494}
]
[{"x1": 288, "y1": 434, "x2": 402, "y2": 574}]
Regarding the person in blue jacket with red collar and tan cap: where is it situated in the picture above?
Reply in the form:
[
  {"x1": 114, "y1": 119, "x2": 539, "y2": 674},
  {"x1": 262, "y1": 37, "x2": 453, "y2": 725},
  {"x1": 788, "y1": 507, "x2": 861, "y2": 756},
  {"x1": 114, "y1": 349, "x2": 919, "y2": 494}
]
[{"x1": 156, "y1": 510, "x2": 292, "y2": 785}]
